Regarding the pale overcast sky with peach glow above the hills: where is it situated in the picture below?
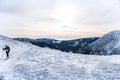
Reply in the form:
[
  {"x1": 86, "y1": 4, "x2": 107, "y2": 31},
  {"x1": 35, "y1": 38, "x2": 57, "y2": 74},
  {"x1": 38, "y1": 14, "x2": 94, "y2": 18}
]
[{"x1": 0, "y1": 0, "x2": 120, "y2": 39}]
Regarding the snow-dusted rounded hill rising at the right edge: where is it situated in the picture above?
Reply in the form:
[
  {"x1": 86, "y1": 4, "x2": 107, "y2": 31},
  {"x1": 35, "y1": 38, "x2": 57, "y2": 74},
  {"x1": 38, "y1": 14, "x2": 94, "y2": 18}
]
[{"x1": 84, "y1": 31, "x2": 120, "y2": 55}]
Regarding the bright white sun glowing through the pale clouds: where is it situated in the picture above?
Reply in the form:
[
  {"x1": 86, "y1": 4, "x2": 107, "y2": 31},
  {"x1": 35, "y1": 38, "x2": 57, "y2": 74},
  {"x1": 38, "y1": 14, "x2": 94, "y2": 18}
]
[{"x1": 55, "y1": 4, "x2": 76, "y2": 26}]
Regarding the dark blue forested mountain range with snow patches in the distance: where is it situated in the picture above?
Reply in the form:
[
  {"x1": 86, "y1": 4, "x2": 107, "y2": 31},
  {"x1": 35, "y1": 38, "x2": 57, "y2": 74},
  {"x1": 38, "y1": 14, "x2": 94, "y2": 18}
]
[{"x1": 14, "y1": 37, "x2": 98, "y2": 53}]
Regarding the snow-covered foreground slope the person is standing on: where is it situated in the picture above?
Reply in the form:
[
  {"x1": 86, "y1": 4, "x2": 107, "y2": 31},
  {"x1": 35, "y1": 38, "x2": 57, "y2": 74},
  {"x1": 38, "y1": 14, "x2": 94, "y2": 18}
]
[{"x1": 0, "y1": 36, "x2": 120, "y2": 80}]
